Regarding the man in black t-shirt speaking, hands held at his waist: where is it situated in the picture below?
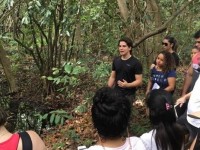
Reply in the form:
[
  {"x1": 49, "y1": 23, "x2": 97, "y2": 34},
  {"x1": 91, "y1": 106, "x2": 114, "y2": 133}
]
[{"x1": 108, "y1": 37, "x2": 142, "y2": 102}]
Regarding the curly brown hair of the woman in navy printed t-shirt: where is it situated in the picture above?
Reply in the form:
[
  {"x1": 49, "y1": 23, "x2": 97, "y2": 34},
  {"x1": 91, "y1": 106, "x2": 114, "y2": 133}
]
[{"x1": 158, "y1": 50, "x2": 175, "y2": 72}]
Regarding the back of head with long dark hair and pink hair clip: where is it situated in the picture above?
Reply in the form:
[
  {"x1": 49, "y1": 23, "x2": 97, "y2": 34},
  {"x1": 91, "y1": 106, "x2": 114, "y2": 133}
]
[{"x1": 146, "y1": 89, "x2": 184, "y2": 150}]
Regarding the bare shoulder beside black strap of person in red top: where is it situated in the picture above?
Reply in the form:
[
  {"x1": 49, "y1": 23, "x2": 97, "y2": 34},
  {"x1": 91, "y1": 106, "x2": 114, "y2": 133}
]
[{"x1": 26, "y1": 130, "x2": 47, "y2": 150}]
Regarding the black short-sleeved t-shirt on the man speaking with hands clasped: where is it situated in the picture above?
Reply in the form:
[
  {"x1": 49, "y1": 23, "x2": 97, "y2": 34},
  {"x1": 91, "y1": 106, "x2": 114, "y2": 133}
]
[{"x1": 112, "y1": 56, "x2": 142, "y2": 95}]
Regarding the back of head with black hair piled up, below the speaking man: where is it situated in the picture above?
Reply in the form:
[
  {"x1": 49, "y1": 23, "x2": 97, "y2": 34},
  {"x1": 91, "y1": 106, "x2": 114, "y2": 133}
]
[{"x1": 91, "y1": 87, "x2": 131, "y2": 139}]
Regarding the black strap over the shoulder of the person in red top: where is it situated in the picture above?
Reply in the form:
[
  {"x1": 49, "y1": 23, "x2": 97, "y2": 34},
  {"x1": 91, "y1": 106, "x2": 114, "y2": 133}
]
[{"x1": 18, "y1": 132, "x2": 33, "y2": 150}]
